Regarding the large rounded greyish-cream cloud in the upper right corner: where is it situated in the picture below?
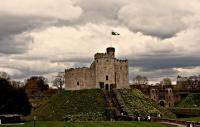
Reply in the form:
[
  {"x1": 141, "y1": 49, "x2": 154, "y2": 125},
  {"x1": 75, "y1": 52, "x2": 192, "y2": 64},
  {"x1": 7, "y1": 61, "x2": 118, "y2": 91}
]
[{"x1": 118, "y1": 0, "x2": 200, "y2": 37}]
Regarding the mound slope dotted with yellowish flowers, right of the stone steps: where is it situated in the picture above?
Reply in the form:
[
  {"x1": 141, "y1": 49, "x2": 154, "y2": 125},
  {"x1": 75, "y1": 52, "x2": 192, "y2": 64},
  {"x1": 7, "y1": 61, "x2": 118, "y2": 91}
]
[{"x1": 120, "y1": 89, "x2": 175, "y2": 118}]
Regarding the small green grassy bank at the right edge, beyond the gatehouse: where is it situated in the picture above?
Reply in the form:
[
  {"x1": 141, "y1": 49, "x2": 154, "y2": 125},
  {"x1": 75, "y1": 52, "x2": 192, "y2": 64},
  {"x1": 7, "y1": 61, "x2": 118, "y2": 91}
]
[{"x1": 176, "y1": 93, "x2": 200, "y2": 108}]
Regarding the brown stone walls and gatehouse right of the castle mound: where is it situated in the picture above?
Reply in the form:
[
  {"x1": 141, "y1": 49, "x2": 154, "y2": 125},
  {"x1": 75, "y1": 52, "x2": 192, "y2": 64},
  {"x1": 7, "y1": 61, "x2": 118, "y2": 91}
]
[{"x1": 130, "y1": 76, "x2": 200, "y2": 107}]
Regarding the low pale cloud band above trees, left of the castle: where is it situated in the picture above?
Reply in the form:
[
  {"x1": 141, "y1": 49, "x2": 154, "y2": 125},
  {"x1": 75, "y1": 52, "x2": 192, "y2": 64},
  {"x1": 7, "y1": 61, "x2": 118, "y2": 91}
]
[{"x1": 0, "y1": 58, "x2": 74, "y2": 78}]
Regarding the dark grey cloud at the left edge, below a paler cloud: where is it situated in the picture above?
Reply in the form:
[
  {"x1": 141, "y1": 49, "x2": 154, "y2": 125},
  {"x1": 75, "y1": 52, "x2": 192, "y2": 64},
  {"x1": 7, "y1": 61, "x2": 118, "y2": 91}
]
[{"x1": 0, "y1": 14, "x2": 54, "y2": 54}]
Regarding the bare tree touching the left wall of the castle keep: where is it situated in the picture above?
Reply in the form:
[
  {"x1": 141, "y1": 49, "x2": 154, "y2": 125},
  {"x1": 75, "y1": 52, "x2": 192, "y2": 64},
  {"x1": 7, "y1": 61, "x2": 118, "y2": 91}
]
[{"x1": 52, "y1": 72, "x2": 64, "y2": 90}]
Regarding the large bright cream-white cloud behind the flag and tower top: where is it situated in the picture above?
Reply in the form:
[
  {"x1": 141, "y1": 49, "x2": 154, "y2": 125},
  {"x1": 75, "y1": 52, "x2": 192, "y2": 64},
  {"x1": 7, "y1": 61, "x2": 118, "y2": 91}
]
[{"x1": 19, "y1": 23, "x2": 177, "y2": 59}]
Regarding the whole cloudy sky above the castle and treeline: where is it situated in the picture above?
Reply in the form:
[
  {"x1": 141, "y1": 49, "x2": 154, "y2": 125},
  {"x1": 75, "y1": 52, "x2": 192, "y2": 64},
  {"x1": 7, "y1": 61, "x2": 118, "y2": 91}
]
[{"x1": 0, "y1": 0, "x2": 200, "y2": 81}]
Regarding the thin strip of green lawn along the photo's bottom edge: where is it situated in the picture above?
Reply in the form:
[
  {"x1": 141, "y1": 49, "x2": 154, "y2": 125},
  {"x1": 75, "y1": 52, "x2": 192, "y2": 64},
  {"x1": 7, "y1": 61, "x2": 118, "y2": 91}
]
[{"x1": 2, "y1": 121, "x2": 175, "y2": 127}]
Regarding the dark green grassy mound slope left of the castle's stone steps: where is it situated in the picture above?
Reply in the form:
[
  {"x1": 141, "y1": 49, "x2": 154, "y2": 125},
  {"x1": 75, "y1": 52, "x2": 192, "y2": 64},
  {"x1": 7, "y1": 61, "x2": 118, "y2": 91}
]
[{"x1": 27, "y1": 89, "x2": 106, "y2": 121}]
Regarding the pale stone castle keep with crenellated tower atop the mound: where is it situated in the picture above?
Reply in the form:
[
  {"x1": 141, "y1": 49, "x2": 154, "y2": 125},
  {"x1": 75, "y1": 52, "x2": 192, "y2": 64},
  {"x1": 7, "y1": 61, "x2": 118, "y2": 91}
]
[{"x1": 65, "y1": 47, "x2": 129, "y2": 90}]
